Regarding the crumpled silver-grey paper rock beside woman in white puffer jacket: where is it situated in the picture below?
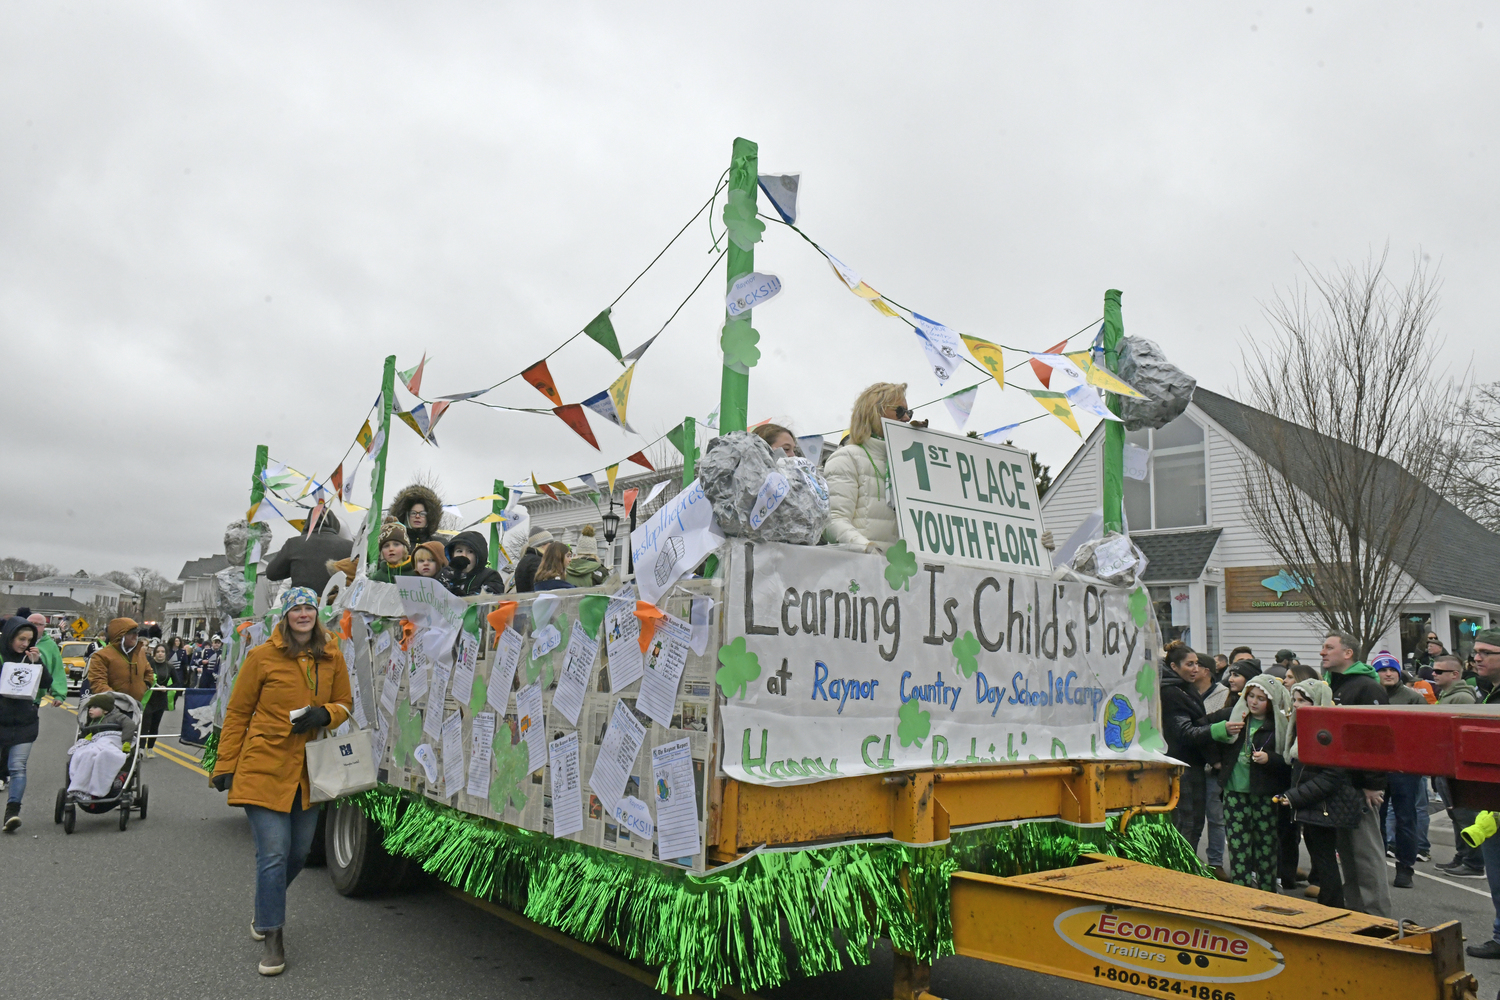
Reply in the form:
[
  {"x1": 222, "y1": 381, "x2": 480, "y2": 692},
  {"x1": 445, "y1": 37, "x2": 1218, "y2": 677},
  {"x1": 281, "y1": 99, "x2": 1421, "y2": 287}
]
[{"x1": 698, "y1": 430, "x2": 828, "y2": 546}]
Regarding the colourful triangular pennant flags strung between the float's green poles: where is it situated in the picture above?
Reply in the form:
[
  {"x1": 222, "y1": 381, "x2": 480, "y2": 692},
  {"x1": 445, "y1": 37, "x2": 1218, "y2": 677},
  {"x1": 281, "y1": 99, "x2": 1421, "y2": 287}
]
[{"x1": 248, "y1": 163, "x2": 1145, "y2": 528}]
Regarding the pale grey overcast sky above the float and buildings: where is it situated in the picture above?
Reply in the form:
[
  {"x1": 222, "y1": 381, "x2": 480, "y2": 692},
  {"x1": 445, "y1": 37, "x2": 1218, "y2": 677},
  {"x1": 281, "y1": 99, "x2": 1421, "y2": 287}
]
[{"x1": 0, "y1": 1, "x2": 1500, "y2": 577}]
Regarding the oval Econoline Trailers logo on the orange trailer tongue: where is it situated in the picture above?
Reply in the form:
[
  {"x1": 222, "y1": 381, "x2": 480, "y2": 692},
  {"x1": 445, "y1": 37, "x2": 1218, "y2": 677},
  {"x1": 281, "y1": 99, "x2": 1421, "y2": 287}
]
[{"x1": 1052, "y1": 906, "x2": 1287, "y2": 982}]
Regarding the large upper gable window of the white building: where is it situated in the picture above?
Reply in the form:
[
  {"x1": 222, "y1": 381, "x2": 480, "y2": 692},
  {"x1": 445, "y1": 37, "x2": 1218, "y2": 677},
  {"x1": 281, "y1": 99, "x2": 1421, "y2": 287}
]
[{"x1": 1124, "y1": 417, "x2": 1209, "y2": 531}]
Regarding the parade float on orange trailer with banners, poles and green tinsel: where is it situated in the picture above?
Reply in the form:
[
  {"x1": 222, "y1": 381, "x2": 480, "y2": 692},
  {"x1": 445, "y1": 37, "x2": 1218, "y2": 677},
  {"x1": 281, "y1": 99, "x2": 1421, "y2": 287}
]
[{"x1": 198, "y1": 139, "x2": 1461, "y2": 1000}]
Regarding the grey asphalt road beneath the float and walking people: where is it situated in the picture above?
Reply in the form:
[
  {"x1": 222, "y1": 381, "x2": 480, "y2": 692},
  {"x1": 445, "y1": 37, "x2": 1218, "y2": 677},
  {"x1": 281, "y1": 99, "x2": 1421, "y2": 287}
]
[{"x1": 0, "y1": 708, "x2": 1500, "y2": 1000}]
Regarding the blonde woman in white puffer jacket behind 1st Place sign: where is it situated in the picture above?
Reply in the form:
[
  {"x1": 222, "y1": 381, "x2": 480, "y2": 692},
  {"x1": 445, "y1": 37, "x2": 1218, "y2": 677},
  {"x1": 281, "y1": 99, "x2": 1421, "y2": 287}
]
[{"x1": 824, "y1": 382, "x2": 912, "y2": 552}]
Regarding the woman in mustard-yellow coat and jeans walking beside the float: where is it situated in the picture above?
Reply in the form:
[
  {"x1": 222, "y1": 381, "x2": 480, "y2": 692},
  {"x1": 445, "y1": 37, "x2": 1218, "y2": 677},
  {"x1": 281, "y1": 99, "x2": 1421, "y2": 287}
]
[{"x1": 213, "y1": 586, "x2": 351, "y2": 976}]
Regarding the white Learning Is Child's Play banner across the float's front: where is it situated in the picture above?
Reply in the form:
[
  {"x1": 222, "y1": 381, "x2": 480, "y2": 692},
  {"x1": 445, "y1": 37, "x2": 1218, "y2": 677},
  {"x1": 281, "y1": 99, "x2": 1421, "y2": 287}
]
[{"x1": 716, "y1": 543, "x2": 1166, "y2": 784}]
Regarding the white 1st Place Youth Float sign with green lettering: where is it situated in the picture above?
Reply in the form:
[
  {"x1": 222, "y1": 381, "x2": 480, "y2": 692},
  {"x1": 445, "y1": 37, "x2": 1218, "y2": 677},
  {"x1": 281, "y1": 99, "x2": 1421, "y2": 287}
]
[{"x1": 884, "y1": 420, "x2": 1052, "y2": 574}]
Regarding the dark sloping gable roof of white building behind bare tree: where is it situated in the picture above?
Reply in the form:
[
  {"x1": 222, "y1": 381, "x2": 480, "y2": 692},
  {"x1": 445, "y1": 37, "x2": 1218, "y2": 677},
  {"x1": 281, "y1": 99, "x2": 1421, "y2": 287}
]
[{"x1": 1182, "y1": 385, "x2": 1500, "y2": 604}]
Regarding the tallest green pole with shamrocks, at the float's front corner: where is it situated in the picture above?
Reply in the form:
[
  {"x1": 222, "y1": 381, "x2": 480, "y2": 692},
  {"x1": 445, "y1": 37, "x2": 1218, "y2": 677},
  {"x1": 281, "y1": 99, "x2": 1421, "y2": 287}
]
[{"x1": 714, "y1": 139, "x2": 765, "y2": 431}]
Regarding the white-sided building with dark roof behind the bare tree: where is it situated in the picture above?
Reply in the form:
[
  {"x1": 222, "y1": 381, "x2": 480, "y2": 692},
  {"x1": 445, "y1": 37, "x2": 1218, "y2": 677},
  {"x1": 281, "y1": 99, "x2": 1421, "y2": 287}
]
[{"x1": 1043, "y1": 387, "x2": 1500, "y2": 664}]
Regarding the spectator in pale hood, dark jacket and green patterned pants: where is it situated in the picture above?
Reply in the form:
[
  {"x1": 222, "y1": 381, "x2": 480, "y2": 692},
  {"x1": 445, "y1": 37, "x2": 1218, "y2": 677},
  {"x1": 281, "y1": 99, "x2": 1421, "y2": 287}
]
[{"x1": 1212, "y1": 676, "x2": 1293, "y2": 892}]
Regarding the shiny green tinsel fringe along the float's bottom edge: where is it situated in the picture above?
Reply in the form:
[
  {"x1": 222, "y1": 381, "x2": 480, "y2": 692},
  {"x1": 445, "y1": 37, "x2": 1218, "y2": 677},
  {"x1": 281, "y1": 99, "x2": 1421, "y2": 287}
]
[{"x1": 357, "y1": 786, "x2": 1208, "y2": 996}]
